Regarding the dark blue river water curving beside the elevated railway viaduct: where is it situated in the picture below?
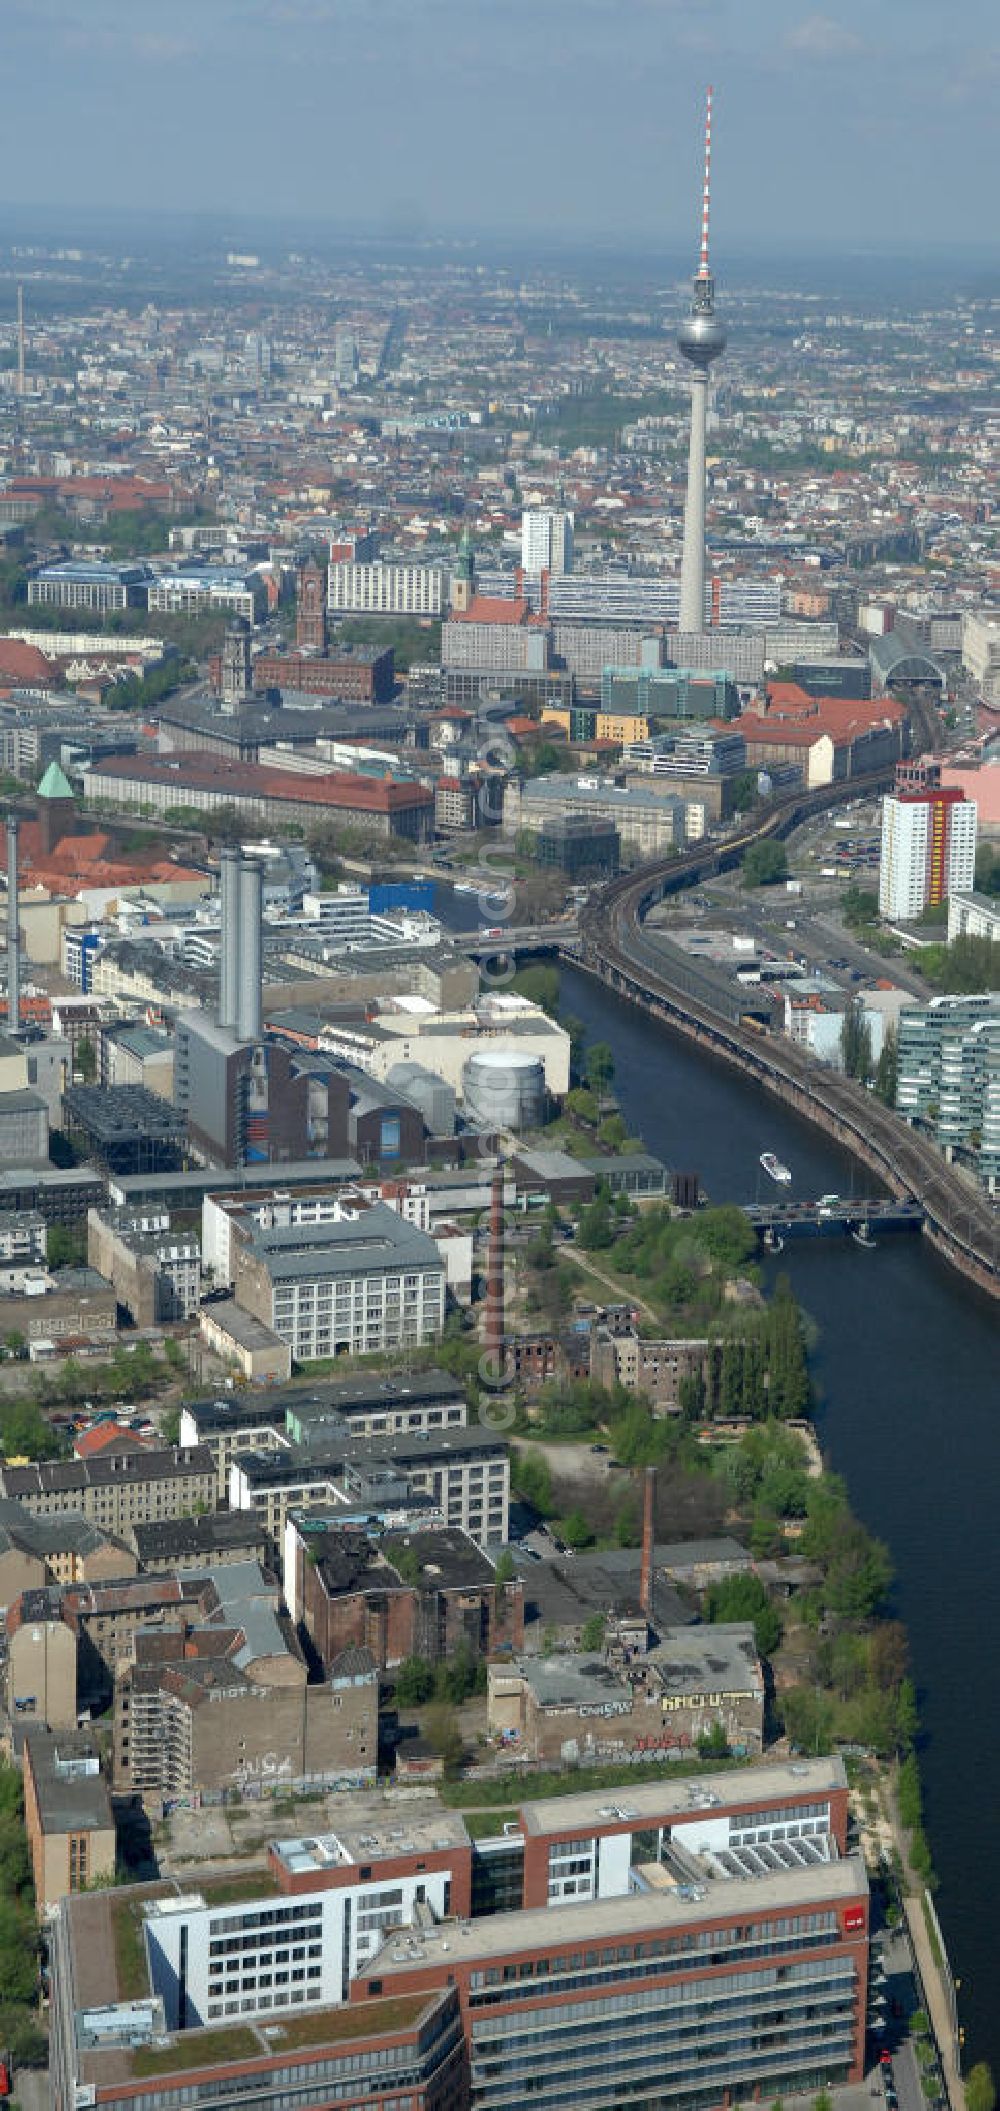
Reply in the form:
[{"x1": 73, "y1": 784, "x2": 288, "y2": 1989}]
[{"x1": 561, "y1": 969, "x2": 1000, "y2": 2075}]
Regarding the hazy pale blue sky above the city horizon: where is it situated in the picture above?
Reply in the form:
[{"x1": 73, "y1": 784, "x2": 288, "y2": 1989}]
[{"x1": 0, "y1": 0, "x2": 1000, "y2": 266}]
